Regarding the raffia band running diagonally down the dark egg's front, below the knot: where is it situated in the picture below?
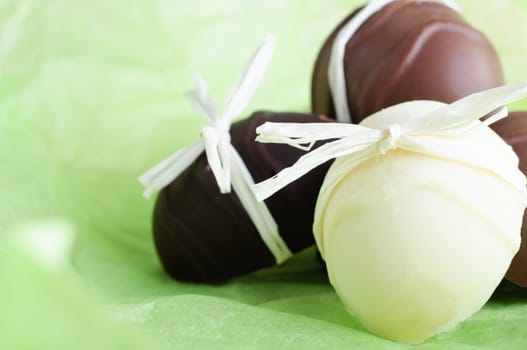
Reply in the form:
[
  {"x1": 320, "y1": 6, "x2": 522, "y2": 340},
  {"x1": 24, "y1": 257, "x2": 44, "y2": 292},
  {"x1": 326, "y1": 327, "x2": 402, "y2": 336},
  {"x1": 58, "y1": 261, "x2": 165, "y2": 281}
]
[{"x1": 231, "y1": 147, "x2": 293, "y2": 264}]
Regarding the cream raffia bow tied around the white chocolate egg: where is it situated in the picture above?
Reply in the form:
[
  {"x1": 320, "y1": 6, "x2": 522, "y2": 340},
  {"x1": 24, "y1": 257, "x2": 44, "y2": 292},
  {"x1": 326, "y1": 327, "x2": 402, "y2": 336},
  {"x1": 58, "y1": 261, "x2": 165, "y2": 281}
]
[{"x1": 253, "y1": 82, "x2": 527, "y2": 200}]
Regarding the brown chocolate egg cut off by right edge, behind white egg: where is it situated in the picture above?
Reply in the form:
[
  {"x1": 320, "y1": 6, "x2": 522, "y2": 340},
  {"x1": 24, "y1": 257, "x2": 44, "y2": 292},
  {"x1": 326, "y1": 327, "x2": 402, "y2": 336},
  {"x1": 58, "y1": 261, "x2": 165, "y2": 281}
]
[{"x1": 491, "y1": 112, "x2": 527, "y2": 287}]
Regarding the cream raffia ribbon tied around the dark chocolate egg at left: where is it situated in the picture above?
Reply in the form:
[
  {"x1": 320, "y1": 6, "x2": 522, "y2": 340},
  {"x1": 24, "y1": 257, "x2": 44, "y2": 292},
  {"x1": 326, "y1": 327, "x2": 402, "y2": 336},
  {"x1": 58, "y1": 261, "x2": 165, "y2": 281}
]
[{"x1": 139, "y1": 36, "x2": 292, "y2": 264}]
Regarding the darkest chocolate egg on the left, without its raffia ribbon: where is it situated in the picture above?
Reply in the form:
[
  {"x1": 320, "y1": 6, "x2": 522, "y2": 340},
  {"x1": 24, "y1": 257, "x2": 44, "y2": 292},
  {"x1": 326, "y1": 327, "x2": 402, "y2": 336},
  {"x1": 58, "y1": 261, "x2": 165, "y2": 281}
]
[{"x1": 153, "y1": 112, "x2": 329, "y2": 283}]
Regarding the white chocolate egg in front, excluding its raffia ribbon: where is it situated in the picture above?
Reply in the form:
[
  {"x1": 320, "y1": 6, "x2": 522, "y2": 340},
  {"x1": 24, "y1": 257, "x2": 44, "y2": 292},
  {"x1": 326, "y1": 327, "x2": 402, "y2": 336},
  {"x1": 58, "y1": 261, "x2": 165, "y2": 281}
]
[{"x1": 314, "y1": 101, "x2": 527, "y2": 343}]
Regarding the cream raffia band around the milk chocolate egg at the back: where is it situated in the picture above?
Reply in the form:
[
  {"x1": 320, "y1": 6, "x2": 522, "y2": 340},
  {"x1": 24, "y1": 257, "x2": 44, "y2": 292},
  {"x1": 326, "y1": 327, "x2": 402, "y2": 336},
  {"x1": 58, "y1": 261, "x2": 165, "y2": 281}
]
[{"x1": 328, "y1": 0, "x2": 459, "y2": 123}]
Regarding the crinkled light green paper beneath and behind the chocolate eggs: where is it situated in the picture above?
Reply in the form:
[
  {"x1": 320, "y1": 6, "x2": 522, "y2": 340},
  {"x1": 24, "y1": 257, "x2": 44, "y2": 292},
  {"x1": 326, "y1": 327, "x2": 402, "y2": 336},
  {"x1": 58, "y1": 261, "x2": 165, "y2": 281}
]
[{"x1": 0, "y1": 0, "x2": 527, "y2": 350}]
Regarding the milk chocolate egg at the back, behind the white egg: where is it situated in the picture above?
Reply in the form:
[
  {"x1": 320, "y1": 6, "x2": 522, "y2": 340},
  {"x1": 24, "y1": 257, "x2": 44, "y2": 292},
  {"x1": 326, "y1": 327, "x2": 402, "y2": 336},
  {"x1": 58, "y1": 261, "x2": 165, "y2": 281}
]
[{"x1": 311, "y1": 1, "x2": 503, "y2": 123}]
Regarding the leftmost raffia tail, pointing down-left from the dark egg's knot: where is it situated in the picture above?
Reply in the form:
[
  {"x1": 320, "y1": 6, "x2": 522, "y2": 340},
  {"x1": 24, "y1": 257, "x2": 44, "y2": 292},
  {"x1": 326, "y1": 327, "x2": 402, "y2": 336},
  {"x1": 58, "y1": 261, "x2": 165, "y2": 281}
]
[{"x1": 138, "y1": 142, "x2": 205, "y2": 198}]
